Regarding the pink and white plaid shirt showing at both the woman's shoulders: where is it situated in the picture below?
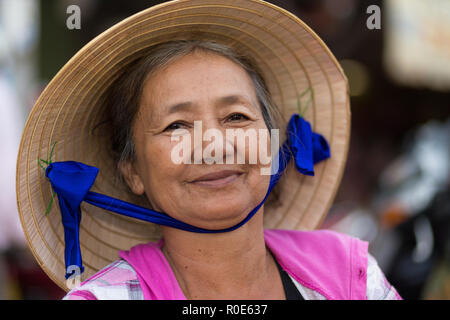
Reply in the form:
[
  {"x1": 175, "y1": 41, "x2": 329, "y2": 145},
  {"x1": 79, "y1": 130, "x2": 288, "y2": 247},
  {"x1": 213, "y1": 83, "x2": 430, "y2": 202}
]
[{"x1": 63, "y1": 254, "x2": 401, "y2": 300}]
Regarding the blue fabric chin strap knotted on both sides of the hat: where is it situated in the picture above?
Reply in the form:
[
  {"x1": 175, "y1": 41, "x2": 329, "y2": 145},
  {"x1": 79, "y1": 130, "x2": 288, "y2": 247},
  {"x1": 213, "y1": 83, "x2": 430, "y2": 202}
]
[{"x1": 45, "y1": 114, "x2": 330, "y2": 279}]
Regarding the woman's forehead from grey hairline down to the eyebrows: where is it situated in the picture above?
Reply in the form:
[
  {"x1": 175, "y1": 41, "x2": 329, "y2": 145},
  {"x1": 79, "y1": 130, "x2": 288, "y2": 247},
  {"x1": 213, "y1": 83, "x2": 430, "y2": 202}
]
[{"x1": 141, "y1": 53, "x2": 256, "y2": 114}]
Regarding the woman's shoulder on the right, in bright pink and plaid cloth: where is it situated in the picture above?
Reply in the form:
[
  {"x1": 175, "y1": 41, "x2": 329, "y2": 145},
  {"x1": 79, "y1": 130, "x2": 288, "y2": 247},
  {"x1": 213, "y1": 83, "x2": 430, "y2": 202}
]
[{"x1": 265, "y1": 230, "x2": 401, "y2": 300}]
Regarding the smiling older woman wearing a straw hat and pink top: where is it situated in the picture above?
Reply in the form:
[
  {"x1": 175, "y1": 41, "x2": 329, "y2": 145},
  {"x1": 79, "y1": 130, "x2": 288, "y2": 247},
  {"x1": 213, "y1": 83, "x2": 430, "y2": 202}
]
[{"x1": 18, "y1": 0, "x2": 400, "y2": 299}]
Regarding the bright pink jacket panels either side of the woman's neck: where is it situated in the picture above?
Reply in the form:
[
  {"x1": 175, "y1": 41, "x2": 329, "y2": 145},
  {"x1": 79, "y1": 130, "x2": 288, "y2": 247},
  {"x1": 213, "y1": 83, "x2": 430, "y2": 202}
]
[{"x1": 120, "y1": 229, "x2": 368, "y2": 300}]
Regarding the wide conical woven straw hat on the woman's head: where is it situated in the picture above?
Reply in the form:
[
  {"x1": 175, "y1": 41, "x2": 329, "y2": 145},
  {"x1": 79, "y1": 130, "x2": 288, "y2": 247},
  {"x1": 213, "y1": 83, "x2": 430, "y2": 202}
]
[{"x1": 16, "y1": 0, "x2": 350, "y2": 290}]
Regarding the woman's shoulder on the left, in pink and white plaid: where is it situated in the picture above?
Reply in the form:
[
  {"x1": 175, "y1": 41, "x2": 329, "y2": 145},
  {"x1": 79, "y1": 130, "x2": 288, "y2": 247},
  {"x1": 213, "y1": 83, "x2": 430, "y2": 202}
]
[{"x1": 63, "y1": 259, "x2": 144, "y2": 300}]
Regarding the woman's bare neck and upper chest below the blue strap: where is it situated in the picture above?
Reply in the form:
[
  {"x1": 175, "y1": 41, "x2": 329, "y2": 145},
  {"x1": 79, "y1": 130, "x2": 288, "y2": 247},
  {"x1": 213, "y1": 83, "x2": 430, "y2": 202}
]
[{"x1": 163, "y1": 213, "x2": 284, "y2": 299}]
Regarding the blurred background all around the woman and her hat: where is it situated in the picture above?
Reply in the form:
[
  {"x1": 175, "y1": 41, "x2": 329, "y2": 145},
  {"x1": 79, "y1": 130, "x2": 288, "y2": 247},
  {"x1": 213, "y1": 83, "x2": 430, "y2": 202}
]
[{"x1": 0, "y1": 0, "x2": 450, "y2": 299}]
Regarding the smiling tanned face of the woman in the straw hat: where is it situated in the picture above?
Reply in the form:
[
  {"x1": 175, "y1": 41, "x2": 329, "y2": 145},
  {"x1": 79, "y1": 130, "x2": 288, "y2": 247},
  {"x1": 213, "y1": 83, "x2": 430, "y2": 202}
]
[{"x1": 121, "y1": 51, "x2": 270, "y2": 229}]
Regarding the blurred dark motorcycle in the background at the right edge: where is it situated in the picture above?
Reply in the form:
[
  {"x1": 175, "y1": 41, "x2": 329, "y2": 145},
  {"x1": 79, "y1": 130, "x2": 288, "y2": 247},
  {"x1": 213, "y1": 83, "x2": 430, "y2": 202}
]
[{"x1": 371, "y1": 119, "x2": 450, "y2": 299}]
